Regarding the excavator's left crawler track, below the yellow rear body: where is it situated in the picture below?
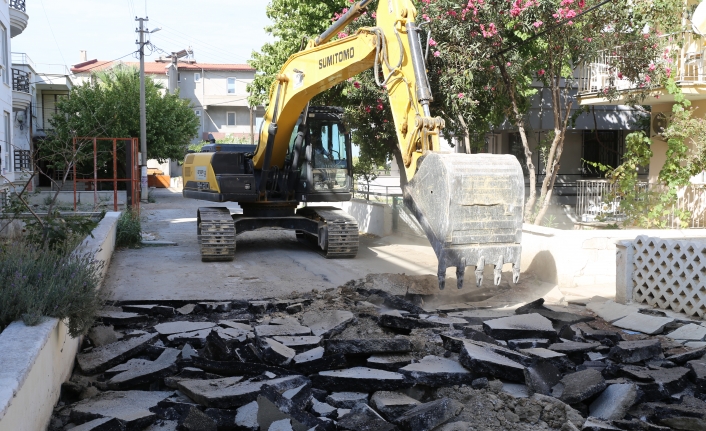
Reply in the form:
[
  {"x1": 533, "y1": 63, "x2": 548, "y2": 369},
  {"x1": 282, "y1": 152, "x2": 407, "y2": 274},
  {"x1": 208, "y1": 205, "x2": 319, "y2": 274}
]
[{"x1": 197, "y1": 208, "x2": 235, "y2": 262}]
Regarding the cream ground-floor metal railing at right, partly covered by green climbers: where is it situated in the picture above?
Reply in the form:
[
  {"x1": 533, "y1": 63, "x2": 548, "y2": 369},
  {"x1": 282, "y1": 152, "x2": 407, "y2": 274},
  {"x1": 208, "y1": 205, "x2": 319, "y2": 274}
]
[{"x1": 576, "y1": 180, "x2": 706, "y2": 228}]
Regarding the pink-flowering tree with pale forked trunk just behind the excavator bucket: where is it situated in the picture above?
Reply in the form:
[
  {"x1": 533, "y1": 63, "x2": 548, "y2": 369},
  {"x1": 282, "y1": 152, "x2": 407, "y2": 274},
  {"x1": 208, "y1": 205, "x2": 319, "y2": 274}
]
[{"x1": 421, "y1": 0, "x2": 679, "y2": 224}]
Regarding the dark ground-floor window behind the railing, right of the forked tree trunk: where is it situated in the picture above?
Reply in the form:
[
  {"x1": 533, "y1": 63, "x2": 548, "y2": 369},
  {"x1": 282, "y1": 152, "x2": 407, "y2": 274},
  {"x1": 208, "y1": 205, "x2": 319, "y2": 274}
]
[{"x1": 583, "y1": 130, "x2": 623, "y2": 177}]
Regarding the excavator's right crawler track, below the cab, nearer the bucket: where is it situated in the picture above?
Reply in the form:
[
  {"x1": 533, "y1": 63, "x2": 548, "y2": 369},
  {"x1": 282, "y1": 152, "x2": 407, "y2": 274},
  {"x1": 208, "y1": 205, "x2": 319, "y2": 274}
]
[{"x1": 297, "y1": 207, "x2": 359, "y2": 259}]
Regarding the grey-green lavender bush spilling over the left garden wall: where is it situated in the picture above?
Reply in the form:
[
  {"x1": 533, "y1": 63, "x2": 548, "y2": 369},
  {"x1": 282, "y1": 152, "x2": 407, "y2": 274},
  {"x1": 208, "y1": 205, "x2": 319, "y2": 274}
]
[{"x1": 0, "y1": 242, "x2": 103, "y2": 337}]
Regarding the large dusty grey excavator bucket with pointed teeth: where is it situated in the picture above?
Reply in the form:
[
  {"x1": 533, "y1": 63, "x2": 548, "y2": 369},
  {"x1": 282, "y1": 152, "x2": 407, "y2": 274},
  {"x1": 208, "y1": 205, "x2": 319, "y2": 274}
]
[{"x1": 404, "y1": 152, "x2": 525, "y2": 290}]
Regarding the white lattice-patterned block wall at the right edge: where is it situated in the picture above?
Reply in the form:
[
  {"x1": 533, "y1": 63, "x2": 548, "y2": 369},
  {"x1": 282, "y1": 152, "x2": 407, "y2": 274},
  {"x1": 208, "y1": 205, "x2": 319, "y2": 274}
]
[{"x1": 617, "y1": 235, "x2": 706, "y2": 318}]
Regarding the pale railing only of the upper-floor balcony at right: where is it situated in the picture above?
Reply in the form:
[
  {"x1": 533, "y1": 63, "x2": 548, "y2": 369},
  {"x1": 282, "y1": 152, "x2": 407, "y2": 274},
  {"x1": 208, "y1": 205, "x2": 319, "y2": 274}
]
[{"x1": 579, "y1": 33, "x2": 706, "y2": 93}]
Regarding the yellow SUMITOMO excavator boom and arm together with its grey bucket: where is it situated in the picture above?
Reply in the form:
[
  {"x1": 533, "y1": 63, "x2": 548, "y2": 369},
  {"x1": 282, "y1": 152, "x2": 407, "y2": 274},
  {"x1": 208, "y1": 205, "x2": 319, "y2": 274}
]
[{"x1": 253, "y1": 0, "x2": 525, "y2": 289}]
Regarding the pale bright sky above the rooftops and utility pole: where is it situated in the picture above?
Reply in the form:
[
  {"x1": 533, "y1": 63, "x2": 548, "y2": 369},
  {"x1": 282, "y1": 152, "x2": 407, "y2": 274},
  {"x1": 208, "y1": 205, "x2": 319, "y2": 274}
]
[{"x1": 11, "y1": 0, "x2": 270, "y2": 68}]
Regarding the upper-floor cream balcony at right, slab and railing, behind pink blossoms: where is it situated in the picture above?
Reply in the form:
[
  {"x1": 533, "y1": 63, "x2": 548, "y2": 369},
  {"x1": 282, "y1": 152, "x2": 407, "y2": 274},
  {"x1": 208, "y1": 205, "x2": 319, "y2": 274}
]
[{"x1": 578, "y1": 33, "x2": 706, "y2": 105}]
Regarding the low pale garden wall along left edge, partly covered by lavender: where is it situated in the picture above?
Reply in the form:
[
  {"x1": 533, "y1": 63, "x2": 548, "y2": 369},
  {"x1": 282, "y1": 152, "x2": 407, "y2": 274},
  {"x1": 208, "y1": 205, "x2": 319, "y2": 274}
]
[{"x1": 0, "y1": 212, "x2": 120, "y2": 431}]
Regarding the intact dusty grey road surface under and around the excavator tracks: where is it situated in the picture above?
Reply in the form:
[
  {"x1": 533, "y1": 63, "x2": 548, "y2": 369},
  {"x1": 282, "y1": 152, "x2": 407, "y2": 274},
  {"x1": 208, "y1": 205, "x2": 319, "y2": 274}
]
[{"x1": 106, "y1": 189, "x2": 547, "y2": 301}]
